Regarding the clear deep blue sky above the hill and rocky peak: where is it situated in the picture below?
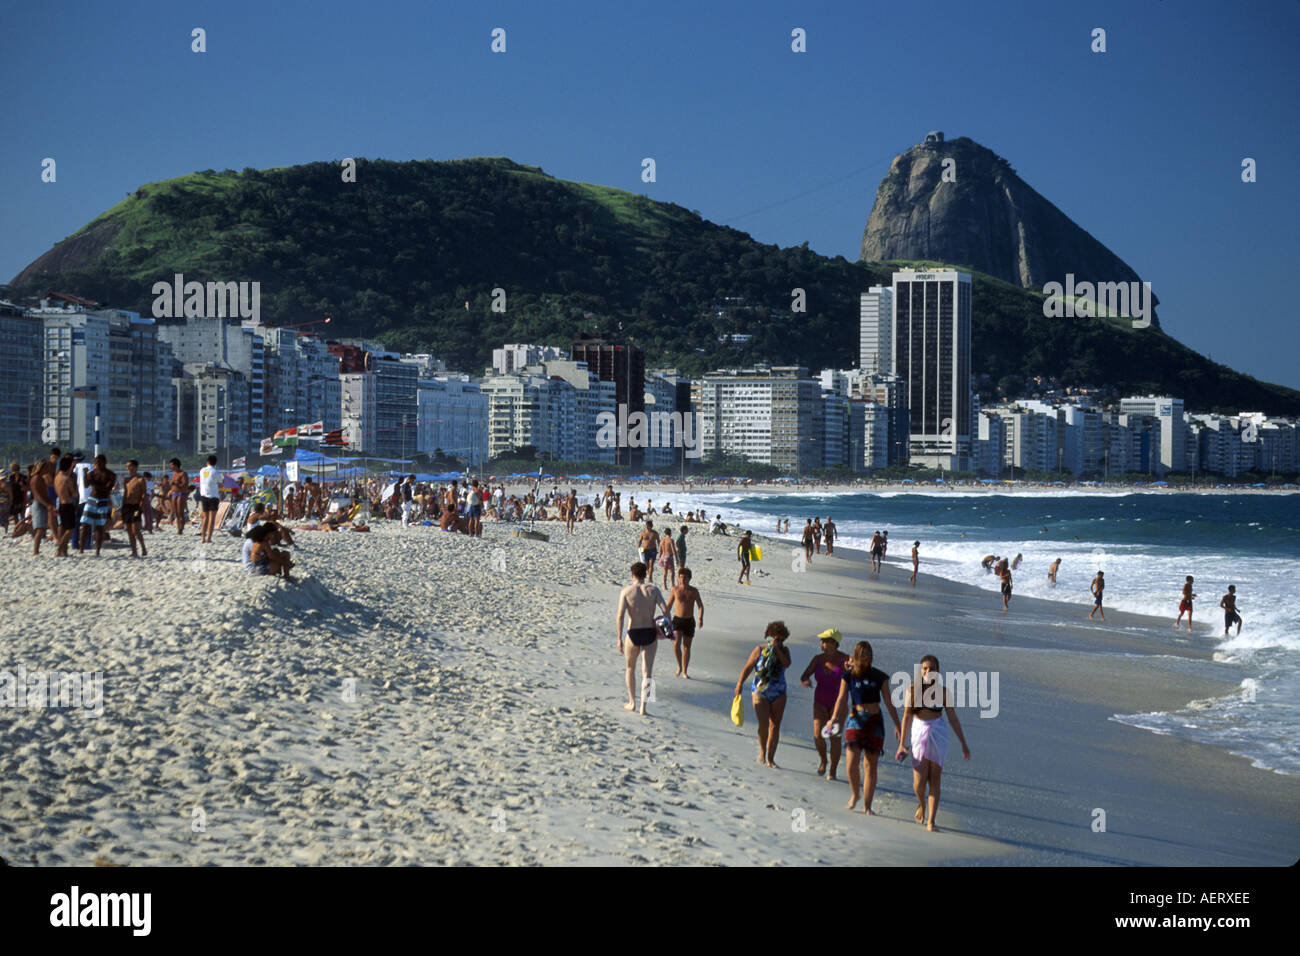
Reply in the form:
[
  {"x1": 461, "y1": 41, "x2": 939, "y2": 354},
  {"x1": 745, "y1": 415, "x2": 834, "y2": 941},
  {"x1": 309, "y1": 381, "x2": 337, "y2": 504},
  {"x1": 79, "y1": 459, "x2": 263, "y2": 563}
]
[{"x1": 0, "y1": 0, "x2": 1300, "y2": 386}]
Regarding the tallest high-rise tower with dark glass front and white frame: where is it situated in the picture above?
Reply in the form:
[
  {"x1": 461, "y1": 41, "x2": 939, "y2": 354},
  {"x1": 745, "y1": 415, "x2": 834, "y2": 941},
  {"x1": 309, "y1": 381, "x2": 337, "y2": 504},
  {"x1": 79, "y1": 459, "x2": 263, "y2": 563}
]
[{"x1": 891, "y1": 269, "x2": 972, "y2": 471}]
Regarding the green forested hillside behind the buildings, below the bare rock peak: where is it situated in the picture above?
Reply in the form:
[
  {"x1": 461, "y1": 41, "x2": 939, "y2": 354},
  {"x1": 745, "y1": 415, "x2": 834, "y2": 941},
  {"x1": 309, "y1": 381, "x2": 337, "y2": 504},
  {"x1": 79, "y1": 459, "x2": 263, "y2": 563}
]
[{"x1": 9, "y1": 159, "x2": 1300, "y2": 414}]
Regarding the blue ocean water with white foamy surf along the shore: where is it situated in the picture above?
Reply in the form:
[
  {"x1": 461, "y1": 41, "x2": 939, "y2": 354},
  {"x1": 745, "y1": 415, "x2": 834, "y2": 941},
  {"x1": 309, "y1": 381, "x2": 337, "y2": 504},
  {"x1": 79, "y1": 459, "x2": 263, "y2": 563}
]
[{"x1": 670, "y1": 490, "x2": 1300, "y2": 774}]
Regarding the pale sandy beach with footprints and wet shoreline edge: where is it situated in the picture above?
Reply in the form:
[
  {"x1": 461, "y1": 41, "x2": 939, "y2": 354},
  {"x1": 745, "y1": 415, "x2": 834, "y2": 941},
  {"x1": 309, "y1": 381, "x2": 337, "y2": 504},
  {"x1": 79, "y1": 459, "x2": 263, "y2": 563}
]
[{"x1": 0, "y1": 494, "x2": 1300, "y2": 866}]
